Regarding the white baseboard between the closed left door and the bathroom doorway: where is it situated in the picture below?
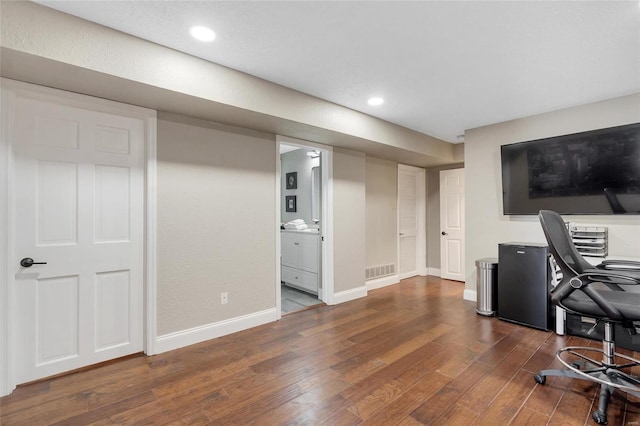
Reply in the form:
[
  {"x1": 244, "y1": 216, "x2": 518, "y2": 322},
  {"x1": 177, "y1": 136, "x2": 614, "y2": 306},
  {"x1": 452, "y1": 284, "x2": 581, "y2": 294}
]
[{"x1": 155, "y1": 308, "x2": 278, "y2": 354}]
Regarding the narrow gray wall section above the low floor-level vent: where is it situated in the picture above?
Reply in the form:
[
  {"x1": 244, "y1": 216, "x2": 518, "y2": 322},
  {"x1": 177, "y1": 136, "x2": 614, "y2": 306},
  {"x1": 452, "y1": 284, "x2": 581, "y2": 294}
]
[{"x1": 365, "y1": 157, "x2": 398, "y2": 270}]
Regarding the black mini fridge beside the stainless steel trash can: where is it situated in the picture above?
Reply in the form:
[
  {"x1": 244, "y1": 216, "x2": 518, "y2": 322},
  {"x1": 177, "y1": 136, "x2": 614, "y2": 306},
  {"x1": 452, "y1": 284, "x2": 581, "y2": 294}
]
[{"x1": 497, "y1": 243, "x2": 554, "y2": 330}]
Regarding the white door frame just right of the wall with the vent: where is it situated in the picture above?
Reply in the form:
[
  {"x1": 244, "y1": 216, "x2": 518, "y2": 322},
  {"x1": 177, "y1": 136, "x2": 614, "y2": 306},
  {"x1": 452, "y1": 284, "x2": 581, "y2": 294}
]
[{"x1": 396, "y1": 163, "x2": 427, "y2": 280}]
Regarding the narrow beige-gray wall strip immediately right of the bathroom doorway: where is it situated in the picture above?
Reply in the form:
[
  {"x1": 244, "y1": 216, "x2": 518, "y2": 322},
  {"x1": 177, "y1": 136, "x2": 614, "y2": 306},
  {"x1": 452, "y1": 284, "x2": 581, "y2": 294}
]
[{"x1": 333, "y1": 149, "x2": 366, "y2": 293}]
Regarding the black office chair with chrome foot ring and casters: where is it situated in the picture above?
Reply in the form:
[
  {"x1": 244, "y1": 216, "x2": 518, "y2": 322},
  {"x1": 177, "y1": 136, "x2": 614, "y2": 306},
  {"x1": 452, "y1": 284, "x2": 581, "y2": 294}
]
[{"x1": 534, "y1": 210, "x2": 640, "y2": 424}]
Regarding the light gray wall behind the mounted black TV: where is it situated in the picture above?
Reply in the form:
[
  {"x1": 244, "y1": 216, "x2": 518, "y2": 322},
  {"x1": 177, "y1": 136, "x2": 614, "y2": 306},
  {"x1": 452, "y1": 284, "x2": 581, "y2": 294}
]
[{"x1": 465, "y1": 94, "x2": 640, "y2": 291}]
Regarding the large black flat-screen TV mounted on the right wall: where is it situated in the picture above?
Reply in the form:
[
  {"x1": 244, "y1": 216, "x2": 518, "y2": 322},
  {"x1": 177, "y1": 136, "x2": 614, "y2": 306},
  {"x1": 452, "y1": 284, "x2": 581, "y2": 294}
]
[{"x1": 501, "y1": 123, "x2": 640, "y2": 215}]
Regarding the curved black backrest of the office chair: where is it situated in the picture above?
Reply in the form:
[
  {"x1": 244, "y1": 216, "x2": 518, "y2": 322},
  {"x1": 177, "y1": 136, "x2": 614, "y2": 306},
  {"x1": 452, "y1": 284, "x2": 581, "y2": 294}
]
[{"x1": 538, "y1": 210, "x2": 593, "y2": 280}]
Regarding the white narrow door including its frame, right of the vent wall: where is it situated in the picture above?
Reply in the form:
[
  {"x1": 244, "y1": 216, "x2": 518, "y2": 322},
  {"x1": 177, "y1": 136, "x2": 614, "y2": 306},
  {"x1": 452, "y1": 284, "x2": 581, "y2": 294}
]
[{"x1": 398, "y1": 164, "x2": 426, "y2": 279}]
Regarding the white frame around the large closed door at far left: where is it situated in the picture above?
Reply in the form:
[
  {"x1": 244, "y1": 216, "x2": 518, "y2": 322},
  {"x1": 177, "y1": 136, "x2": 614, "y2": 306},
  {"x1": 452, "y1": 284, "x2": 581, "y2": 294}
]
[{"x1": 0, "y1": 78, "x2": 157, "y2": 396}]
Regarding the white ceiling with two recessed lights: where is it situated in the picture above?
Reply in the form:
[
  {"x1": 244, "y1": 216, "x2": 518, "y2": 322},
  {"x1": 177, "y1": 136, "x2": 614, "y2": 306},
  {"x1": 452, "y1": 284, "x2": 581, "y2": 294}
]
[{"x1": 37, "y1": 0, "x2": 640, "y2": 142}]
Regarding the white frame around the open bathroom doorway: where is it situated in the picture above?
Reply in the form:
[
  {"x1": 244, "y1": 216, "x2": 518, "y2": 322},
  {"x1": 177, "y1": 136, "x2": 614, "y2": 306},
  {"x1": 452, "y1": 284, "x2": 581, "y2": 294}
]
[{"x1": 275, "y1": 135, "x2": 335, "y2": 320}]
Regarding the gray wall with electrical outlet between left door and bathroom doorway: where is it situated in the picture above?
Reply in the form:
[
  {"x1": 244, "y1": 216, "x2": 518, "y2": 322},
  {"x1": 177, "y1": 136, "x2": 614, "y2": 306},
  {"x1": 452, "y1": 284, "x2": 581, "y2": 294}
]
[{"x1": 157, "y1": 115, "x2": 276, "y2": 335}]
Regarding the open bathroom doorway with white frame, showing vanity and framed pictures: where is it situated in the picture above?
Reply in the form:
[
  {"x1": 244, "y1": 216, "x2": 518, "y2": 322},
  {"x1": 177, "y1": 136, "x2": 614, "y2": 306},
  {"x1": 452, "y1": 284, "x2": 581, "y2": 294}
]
[{"x1": 276, "y1": 137, "x2": 333, "y2": 316}]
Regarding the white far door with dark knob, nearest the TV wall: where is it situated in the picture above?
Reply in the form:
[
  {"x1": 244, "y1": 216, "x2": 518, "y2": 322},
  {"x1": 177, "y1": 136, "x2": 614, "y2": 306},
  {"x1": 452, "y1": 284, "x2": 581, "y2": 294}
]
[{"x1": 440, "y1": 169, "x2": 465, "y2": 281}]
